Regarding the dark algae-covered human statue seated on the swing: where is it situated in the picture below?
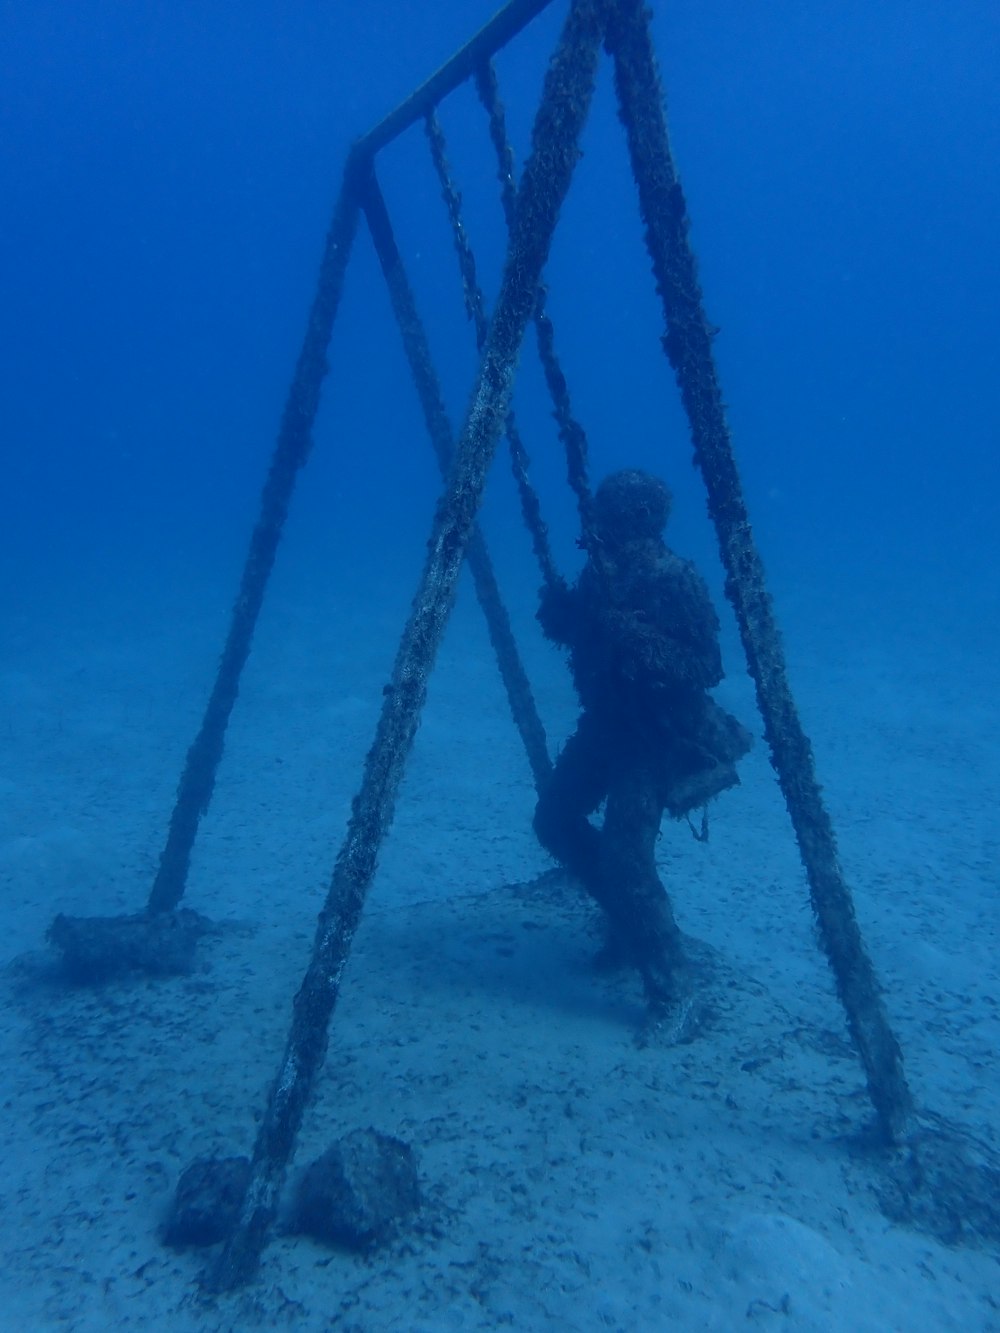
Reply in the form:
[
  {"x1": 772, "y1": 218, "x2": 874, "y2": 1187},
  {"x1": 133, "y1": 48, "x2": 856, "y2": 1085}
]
[{"x1": 535, "y1": 471, "x2": 751, "y2": 1040}]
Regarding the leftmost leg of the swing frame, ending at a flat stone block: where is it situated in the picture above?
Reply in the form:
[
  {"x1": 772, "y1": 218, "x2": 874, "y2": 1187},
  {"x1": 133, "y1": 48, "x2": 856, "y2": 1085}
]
[{"x1": 147, "y1": 166, "x2": 357, "y2": 912}]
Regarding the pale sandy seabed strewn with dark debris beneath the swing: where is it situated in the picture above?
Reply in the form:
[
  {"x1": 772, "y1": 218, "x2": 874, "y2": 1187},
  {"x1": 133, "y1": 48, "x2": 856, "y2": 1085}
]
[{"x1": 0, "y1": 557, "x2": 1000, "y2": 1333}]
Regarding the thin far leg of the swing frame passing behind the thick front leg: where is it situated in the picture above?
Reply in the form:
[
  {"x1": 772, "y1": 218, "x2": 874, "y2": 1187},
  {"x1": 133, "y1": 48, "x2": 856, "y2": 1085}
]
[{"x1": 361, "y1": 171, "x2": 552, "y2": 788}]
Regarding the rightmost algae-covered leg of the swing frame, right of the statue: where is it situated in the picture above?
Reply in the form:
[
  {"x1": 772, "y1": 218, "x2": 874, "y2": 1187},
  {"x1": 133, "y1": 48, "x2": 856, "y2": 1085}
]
[{"x1": 608, "y1": 0, "x2": 913, "y2": 1142}]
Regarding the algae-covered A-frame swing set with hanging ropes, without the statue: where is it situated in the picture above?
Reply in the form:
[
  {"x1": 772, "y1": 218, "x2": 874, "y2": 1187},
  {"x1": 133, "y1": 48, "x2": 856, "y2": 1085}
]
[{"x1": 51, "y1": 0, "x2": 1000, "y2": 1292}]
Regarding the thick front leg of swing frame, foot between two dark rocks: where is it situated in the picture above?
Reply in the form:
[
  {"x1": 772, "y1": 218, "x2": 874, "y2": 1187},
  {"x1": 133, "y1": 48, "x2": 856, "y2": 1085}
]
[{"x1": 211, "y1": 0, "x2": 605, "y2": 1290}]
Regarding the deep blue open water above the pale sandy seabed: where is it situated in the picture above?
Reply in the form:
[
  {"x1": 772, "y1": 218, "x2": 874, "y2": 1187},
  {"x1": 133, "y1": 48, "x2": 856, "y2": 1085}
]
[{"x1": 0, "y1": 0, "x2": 1000, "y2": 613}]
